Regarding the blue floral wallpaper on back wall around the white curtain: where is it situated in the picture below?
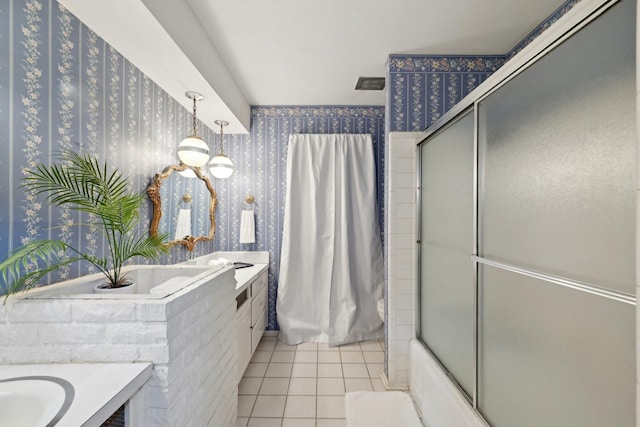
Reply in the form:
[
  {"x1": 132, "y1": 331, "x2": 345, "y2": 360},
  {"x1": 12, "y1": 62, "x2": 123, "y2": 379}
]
[{"x1": 214, "y1": 106, "x2": 385, "y2": 329}]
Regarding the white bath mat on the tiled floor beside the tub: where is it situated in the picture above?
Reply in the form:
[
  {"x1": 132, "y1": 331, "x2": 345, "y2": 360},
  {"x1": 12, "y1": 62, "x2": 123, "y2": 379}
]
[{"x1": 344, "y1": 391, "x2": 422, "y2": 427}]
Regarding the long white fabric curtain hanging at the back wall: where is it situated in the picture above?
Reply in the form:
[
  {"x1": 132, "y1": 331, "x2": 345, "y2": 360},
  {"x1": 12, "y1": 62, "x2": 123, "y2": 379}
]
[{"x1": 276, "y1": 134, "x2": 384, "y2": 346}]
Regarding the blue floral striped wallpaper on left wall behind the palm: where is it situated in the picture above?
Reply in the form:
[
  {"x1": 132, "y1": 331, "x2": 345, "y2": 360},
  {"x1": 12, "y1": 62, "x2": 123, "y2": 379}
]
[{"x1": 0, "y1": 0, "x2": 214, "y2": 281}]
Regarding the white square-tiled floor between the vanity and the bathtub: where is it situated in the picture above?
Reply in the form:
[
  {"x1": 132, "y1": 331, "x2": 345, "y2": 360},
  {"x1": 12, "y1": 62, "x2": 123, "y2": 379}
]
[{"x1": 236, "y1": 335, "x2": 384, "y2": 427}]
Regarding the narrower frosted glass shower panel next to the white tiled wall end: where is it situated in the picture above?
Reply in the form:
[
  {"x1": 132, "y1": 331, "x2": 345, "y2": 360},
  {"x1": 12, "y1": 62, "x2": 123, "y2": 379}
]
[{"x1": 418, "y1": 111, "x2": 475, "y2": 396}]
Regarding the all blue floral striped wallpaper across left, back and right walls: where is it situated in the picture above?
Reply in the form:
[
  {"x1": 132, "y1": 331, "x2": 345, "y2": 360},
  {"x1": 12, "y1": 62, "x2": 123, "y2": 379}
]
[{"x1": 0, "y1": 0, "x2": 578, "y2": 329}]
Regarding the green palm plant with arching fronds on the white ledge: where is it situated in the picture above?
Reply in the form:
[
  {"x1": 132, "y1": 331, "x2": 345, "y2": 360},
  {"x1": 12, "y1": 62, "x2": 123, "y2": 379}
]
[{"x1": 0, "y1": 151, "x2": 167, "y2": 295}]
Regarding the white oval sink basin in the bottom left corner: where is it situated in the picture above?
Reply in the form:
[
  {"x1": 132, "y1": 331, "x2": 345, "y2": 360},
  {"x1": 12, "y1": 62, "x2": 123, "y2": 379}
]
[{"x1": 0, "y1": 376, "x2": 74, "y2": 427}]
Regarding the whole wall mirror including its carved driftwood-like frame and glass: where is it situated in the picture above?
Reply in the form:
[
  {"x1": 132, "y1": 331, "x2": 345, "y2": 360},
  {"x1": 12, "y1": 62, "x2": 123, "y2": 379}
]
[{"x1": 147, "y1": 163, "x2": 218, "y2": 252}]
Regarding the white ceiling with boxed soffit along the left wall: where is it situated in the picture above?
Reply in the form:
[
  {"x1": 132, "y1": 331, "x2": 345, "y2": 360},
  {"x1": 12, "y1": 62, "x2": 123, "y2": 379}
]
[{"x1": 59, "y1": 0, "x2": 563, "y2": 133}]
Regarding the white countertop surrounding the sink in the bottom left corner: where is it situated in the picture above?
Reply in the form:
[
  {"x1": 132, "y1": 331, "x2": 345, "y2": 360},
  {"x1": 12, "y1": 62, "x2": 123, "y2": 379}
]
[{"x1": 0, "y1": 363, "x2": 152, "y2": 427}]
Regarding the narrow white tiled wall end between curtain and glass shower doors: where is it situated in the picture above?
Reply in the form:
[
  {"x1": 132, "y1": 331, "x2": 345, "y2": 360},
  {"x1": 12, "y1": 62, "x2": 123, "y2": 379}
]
[{"x1": 385, "y1": 132, "x2": 419, "y2": 388}]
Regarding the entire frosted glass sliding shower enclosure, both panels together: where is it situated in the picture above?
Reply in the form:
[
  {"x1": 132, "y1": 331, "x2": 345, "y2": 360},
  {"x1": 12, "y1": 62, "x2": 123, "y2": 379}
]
[{"x1": 418, "y1": 0, "x2": 637, "y2": 427}]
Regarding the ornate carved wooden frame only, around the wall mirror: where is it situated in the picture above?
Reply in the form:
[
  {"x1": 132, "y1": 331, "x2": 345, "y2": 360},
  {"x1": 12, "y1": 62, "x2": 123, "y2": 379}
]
[{"x1": 147, "y1": 163, "x2": 218, "y2": 252}]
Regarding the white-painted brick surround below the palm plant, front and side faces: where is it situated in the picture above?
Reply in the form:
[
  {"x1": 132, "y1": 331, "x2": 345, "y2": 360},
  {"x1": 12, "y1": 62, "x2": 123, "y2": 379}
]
[{"x1": 0, "y1": 266, "x2": 237, "y2": 427}]
